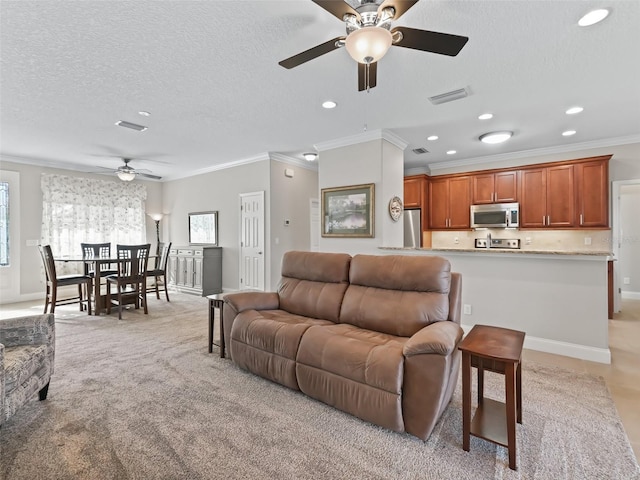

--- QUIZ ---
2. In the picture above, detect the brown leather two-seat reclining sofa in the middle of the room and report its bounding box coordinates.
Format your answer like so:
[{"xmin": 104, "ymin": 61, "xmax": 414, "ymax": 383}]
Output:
[{"xmin": 224, "ymin": 252, "xmax": 463, "ymax": 440}]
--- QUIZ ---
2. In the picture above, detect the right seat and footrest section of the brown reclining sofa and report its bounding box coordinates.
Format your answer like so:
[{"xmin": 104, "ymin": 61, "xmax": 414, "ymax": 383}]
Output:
[{"xmin": 296, "ymin": 324, "xmax": 406, "ymax": 431}]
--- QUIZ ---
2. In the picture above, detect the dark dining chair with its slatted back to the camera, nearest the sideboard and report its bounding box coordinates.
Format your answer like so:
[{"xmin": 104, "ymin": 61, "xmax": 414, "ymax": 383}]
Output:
[{"xmin": 106, "ymin": 243, "xmax": 151, "ymax": 319}]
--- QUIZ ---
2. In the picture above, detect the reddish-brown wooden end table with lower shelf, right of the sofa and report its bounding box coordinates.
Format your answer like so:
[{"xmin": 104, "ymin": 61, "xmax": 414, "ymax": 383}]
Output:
[{"xmin": 458, "ymin": 325, "xmax": 525, "ymax": 470}]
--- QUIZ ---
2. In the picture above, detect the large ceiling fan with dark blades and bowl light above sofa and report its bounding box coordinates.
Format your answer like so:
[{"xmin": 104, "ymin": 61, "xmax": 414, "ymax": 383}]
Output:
[{"xmin": 279, "ymin": 0, "xmax": 469, "ymax": 91}]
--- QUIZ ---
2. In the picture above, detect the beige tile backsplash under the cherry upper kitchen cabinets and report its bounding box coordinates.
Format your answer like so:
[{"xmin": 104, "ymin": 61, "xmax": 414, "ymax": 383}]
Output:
[{"xmin": 431, "ymin": 228, "xmax": 612, "ymax": 252}]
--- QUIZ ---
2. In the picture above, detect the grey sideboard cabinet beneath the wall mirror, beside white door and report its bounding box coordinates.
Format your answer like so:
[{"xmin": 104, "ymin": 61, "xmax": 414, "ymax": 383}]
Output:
[{"xmin": 167, "ymin": 245, "xmax": 222, "ymax": 297}]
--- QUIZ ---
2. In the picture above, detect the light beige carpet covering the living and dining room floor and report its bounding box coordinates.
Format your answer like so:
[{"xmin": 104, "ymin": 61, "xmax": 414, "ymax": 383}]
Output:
[{"xmin": 0, "ymin": 295, "xmax": 640, "ymax": 480}]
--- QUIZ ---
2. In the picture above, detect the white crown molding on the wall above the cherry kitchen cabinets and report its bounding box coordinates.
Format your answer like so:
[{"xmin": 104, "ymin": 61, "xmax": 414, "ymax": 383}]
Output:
[{"xmin": 427, "ymin": 135, "xmax": 640, "ymax": 173}]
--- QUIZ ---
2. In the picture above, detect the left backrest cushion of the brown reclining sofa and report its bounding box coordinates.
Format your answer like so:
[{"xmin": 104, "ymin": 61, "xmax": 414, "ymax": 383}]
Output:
[{"xmin": 278, "ymin": 251, "xmax": 351, "ymax": 322}]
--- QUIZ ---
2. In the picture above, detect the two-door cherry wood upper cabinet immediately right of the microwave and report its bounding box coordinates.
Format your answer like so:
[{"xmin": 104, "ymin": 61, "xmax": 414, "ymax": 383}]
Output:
[{"xmin": 520, "ymin": 164, "xmax": 576, "ymax": 228}]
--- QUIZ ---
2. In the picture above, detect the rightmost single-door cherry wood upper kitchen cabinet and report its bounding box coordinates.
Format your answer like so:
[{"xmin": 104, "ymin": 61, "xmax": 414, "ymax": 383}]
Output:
[{"xmin": 575, "ymin": 155, "xmax": 611, "ymax": 228}]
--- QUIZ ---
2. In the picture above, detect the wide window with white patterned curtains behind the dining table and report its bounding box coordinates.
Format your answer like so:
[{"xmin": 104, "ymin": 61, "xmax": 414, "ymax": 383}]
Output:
[{"xmin": 41, "ymin": 174, "xmax": 147, "ymax": 274}]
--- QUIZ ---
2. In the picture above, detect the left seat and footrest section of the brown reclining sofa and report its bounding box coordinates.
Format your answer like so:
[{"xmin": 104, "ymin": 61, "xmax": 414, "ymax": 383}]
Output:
[{"xmin": 230, "ymin": 310, "xmax": 333, "ymax": 390}]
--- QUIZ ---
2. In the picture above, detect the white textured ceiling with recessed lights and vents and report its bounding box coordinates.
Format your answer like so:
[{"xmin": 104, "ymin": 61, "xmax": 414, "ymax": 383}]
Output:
[{"xmin": 0, "ymin": 0, "xmax": 640, "ymax": 179}]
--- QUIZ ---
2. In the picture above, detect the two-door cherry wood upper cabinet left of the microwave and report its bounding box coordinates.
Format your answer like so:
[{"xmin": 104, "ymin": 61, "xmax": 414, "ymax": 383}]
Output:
[{"xmin": 428, "ymin": 175, "xmax": 471, "ymax": 230}]
